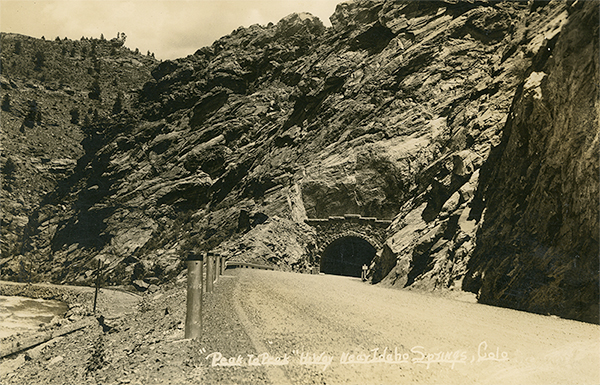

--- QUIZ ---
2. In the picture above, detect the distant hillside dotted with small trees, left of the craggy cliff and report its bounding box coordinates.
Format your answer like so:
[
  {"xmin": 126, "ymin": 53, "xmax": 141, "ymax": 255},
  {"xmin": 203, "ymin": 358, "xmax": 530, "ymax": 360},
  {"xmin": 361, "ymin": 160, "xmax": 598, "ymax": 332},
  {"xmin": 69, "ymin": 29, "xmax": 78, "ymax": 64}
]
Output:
[{"xmin": 0, "ymin": 33, "xmax": 156, "ymax": 271}]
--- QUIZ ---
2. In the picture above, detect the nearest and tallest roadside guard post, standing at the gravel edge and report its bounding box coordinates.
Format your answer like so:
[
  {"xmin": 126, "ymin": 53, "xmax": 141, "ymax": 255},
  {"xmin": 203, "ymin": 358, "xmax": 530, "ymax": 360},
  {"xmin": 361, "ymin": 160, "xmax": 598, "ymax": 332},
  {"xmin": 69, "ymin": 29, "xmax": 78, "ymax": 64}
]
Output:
[{"xmin": 185, "ymin": 255, "xmax": 203, "ymax": 339}]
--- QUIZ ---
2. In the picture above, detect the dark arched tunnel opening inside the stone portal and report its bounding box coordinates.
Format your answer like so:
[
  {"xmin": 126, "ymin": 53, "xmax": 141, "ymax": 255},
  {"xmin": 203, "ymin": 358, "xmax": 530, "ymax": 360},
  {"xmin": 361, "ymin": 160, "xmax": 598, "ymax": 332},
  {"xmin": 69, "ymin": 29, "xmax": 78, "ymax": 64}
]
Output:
[{"xmin": 320, "ymin": 236, "xmax": 377, "ymax": 277}]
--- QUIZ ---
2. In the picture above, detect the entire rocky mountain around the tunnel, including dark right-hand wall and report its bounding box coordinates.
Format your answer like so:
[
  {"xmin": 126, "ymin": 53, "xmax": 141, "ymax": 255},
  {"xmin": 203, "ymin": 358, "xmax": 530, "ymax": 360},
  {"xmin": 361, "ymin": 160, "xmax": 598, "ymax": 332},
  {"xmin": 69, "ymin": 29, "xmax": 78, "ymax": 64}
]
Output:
[{"xmin": 1, "ymin": 0, "xmax": 598, "ymax": 322}]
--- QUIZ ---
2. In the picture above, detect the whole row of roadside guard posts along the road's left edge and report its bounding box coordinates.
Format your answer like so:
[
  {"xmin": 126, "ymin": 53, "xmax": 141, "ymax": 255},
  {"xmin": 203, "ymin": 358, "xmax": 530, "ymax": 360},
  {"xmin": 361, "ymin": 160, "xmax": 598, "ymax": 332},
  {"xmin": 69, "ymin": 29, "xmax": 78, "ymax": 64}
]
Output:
[{"xmin": 185, "ymin": 252, "xmax": 226, "ymax": 339}]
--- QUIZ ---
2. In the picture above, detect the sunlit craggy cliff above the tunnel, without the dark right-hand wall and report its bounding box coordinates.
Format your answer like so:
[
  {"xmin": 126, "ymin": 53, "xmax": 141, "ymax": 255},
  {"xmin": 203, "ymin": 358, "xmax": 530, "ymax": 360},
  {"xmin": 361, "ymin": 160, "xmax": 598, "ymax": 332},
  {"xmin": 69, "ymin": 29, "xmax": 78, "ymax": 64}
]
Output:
[{"xmin": 2, "ymin": 0, "xmax": 597, "ymax": 317}]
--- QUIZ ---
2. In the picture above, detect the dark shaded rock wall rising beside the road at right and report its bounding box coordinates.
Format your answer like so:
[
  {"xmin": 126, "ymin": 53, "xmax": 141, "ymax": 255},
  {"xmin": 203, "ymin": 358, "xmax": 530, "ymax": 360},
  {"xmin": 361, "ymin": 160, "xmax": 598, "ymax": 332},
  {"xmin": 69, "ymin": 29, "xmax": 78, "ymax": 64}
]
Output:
[{"xmin": 465, "ymin": 2, "xmax": 600, "ymax": 323}]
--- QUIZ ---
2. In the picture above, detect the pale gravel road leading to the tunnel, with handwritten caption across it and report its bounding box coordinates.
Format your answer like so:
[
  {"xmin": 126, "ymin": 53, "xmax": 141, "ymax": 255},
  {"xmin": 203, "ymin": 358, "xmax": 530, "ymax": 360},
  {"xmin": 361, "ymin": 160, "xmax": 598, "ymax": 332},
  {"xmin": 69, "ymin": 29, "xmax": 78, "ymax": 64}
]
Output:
[{"xmin": 221, "ymin": 269, "xmax": 600, "ymax": 384}]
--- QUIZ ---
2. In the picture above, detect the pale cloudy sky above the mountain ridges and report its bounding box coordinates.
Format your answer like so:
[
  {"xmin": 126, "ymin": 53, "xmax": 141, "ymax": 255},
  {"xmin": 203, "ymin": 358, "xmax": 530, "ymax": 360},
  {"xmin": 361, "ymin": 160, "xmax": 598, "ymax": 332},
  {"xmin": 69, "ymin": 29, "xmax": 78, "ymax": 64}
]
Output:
[{"xmin": 0, "ymin": 0, "xmax": 344, "ymax": 60}]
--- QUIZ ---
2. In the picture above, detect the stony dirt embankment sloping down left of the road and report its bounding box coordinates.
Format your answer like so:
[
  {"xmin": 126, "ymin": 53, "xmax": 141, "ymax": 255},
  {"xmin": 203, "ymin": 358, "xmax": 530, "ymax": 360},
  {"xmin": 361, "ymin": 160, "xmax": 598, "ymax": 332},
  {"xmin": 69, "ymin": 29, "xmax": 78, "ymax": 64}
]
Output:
[{"xmin": 0, "ymin": 271, "xmax": 269, "ymax": 385}]
